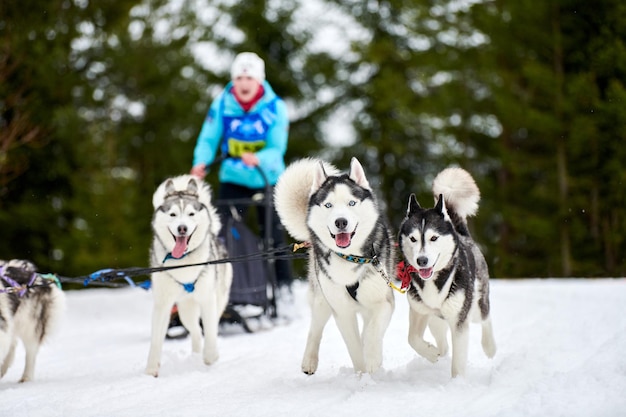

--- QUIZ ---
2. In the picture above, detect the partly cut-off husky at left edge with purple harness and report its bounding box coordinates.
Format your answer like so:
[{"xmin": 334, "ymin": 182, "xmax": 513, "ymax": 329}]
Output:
[{"xmin": 0, "ymin": 259, "xmax": 65, "ymax": 382}]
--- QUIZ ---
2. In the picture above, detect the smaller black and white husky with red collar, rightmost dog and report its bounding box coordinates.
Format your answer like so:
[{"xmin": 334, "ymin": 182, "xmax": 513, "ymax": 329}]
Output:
[{"xmin": 399, "ymin": 168, "xmax": 496, "ymax": 377}]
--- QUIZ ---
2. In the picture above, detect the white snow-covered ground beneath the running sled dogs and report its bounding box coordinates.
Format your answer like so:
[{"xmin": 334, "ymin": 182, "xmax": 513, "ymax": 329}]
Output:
[{"xmin": 0, "ymin": 279, "xmax": 626, "ymax": 417}]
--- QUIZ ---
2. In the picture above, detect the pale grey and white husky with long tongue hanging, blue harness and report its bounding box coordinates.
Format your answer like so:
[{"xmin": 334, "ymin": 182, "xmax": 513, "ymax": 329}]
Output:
[{"xmin": 146, "ymin": 175, "xmax": 233, "ymax": 377}]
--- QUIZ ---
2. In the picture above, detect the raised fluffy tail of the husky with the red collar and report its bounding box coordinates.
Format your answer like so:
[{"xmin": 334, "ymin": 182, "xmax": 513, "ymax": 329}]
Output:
[{"xmin": 433, "ymin": 168, "xmax": 480, "ymax": 220}]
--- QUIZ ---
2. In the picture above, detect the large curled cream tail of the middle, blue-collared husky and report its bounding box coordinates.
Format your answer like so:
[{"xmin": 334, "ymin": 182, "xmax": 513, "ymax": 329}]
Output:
[{"xmin": 274, "ymin": 158, "xmax": 339, "ymax": 241}]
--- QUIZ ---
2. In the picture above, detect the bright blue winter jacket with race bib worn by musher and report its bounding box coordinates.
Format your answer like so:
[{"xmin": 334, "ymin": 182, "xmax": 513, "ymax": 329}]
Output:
[{"xmin": 193, "ymin": 81, "xmax": 289, "ymax": 188}]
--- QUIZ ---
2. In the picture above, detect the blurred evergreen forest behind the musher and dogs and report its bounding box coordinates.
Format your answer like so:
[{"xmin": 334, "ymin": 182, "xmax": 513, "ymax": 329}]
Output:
[{"xmin": 0, "ymin": 0, "xmax": 626, "ymax": 278}]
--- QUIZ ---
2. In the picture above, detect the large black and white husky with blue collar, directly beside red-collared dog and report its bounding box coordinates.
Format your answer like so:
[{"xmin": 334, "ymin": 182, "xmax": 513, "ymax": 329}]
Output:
[{"xmin": 275, "ymin": 158, "xmax": 395, "ymax": 374}]
